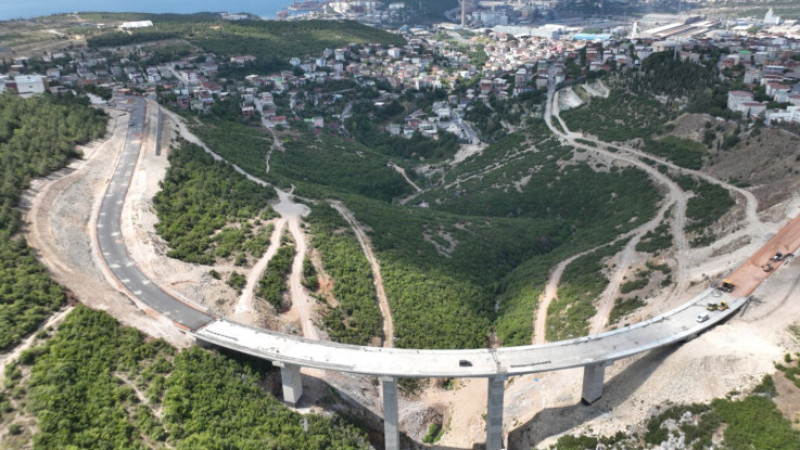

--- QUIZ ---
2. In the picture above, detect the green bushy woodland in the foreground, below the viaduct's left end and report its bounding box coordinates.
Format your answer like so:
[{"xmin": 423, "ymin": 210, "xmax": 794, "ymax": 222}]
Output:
[{"xmin": 0, "ymin": 307, "xmax": 369, "ymax": 450}]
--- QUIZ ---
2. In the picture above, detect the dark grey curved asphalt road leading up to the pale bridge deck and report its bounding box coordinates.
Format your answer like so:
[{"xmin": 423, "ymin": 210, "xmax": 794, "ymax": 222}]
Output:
[{"xmin": 97, "ymin": 98, "xmax": 214, "ymax": 330}]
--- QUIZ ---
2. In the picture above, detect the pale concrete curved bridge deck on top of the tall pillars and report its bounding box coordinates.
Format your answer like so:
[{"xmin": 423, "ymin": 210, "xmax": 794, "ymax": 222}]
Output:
[{"xmin": 194, "ymin": 289, "xmax": 746, "ymax": 377}]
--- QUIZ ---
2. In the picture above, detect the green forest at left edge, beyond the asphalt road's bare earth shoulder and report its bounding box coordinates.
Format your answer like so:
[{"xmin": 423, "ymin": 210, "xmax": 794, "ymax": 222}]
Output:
[{"xmin": 0, "ymin": 94, "xmax": 106, "ymax": 351}]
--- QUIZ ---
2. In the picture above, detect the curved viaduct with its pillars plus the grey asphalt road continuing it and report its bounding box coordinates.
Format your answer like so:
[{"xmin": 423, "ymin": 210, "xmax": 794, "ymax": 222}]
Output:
[{"xmin": 96, "ymin": 98, "xmax": 747, "ymax": 450}]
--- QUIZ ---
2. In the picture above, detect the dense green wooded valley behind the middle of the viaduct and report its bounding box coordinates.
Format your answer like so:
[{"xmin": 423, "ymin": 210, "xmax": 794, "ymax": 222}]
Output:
[{"xmin": 181, "ymin": 101, "xmax": 659, "ymax": 348}]
